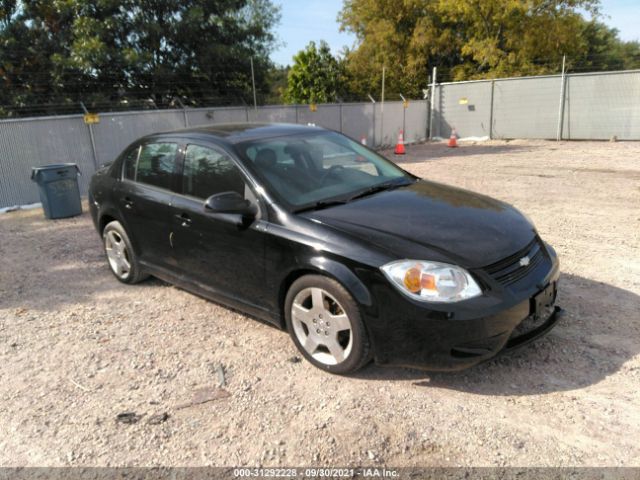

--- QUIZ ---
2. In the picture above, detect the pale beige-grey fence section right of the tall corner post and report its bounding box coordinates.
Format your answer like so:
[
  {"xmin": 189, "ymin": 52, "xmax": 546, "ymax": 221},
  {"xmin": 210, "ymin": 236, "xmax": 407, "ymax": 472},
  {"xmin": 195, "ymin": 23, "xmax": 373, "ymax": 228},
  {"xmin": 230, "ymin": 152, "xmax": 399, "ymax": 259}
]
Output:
[{"xmin": 431, "ymin": 70, "xmax": 640, "ymax": 140}]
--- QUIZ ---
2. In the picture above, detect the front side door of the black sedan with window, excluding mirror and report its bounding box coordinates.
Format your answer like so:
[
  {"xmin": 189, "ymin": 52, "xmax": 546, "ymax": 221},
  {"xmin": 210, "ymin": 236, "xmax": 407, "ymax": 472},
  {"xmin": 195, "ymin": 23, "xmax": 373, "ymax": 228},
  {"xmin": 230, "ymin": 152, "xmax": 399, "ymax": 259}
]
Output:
[{"xmin": 171, "ymin": 144, "xmax": 265, "ymax": 308}]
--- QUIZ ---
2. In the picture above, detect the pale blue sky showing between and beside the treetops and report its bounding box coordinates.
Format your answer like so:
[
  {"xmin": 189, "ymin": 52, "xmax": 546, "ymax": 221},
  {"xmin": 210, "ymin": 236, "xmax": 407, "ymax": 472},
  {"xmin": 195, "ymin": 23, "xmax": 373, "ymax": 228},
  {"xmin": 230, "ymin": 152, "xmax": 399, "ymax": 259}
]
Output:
[{"xmin": 271, "ymin": 0, "xmax": 640, "ymax": 65}]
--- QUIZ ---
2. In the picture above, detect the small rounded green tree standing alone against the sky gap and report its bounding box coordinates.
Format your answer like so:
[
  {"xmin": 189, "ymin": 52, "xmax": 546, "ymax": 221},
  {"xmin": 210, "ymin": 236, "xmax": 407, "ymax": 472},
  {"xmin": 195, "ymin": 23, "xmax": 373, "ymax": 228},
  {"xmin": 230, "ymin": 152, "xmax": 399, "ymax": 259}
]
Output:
[{"xmin": 285, "ymin": 41, "xmax": 344, "ymax": 103}]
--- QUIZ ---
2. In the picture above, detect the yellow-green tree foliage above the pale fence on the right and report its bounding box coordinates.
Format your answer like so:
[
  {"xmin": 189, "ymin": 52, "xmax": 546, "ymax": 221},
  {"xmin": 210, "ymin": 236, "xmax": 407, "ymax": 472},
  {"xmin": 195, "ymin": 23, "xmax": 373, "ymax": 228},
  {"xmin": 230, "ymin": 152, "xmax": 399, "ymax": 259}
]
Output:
[{"xmin": 339, "ymin": 0, "xmax": 640, "ymax": 96}]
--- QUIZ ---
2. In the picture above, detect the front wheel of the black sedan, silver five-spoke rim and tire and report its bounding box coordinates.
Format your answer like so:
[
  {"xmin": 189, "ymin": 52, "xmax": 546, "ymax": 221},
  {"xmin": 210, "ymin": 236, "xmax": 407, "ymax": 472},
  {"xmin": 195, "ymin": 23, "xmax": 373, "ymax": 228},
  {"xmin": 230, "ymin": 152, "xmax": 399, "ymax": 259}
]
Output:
[{"xmin": 285, "ymin": 275, "xmax": 371, "ymax": 374}]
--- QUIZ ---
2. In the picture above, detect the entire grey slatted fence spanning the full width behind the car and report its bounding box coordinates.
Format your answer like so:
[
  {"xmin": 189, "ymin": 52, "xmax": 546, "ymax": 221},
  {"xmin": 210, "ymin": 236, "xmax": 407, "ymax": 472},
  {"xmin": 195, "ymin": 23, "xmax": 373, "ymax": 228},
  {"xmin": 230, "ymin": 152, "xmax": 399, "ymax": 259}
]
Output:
[{"xmin": 0, "ymin": 70, "xmax": 640, "ymax": 208}]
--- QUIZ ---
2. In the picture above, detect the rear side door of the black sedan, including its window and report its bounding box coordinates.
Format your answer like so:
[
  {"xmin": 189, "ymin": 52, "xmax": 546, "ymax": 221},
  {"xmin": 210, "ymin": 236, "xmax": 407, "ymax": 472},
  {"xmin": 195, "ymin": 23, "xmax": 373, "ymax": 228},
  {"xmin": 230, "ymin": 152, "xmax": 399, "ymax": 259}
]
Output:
[{"xmin": 116, "ymin": 141, "xmax": 180, "ymax": 266}]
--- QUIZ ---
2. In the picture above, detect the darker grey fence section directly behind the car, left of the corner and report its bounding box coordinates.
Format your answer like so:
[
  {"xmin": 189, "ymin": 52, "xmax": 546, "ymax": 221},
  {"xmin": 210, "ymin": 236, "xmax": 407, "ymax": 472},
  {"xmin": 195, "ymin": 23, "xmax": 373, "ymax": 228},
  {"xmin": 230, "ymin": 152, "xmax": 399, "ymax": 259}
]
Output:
[{"xmin": 0, "ymin": 100, "xmax": 428, "ymax": 208}]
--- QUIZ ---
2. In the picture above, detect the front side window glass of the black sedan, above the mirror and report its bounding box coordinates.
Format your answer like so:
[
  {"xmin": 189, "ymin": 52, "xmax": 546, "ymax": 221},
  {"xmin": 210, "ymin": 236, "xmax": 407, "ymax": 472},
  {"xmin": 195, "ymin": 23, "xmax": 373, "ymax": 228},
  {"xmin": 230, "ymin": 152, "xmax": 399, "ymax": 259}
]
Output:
[{"xmin": 182, "ymin": 145, "xmax": 245, "ymax": 199}]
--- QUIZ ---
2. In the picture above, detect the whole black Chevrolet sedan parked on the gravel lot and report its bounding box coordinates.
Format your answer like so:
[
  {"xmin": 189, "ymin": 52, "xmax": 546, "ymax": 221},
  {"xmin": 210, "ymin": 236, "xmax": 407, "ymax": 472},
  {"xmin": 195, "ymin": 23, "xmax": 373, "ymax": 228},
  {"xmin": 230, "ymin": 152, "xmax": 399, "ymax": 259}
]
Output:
[{"xmin": 89, "ymin": 124, "xmax": 559, "ymax": 373}]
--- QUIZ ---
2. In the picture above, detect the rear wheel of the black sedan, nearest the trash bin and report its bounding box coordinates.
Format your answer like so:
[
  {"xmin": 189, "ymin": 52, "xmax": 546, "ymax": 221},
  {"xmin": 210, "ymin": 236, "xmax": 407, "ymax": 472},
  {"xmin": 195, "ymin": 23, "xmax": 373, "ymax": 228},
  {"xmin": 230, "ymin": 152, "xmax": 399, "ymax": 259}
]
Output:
[{"xmin": 102, "ymin": 220, "xmax": 149, "ymax": 284}]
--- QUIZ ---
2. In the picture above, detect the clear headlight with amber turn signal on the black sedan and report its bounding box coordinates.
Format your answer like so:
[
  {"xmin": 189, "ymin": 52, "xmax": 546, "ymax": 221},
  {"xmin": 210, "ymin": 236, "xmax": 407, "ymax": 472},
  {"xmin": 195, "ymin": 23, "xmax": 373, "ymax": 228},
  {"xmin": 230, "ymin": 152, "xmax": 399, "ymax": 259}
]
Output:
[{"xmin": 380, "ymin": 260, "xmax": 482, "ymax": 302}]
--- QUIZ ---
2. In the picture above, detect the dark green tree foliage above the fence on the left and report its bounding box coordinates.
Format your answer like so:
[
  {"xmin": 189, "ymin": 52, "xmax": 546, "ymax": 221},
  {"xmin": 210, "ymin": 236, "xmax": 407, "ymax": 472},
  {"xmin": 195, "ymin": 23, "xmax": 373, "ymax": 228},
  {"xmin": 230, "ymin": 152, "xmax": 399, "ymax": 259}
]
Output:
[{"xmin": 0, "ymin": 0, "xmax": 279, "ymax": 114}]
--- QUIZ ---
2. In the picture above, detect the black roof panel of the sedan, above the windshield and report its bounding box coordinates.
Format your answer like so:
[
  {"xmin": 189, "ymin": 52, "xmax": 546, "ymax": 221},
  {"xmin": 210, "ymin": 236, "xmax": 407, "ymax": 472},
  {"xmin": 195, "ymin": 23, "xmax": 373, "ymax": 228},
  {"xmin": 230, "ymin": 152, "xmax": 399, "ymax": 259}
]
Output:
[{"xmin": 145, "ymin": 123, "xmax": 324, "ymax": 144}]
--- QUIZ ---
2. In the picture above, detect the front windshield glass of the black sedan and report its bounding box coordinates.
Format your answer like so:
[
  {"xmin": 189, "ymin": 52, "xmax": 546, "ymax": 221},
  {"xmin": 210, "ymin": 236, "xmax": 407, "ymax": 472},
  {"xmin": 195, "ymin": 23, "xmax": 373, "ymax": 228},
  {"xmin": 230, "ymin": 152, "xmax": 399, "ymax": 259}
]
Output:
[{"xmin": 238, "ymin": 132, "xmax": 413, "ymax": 210}]
